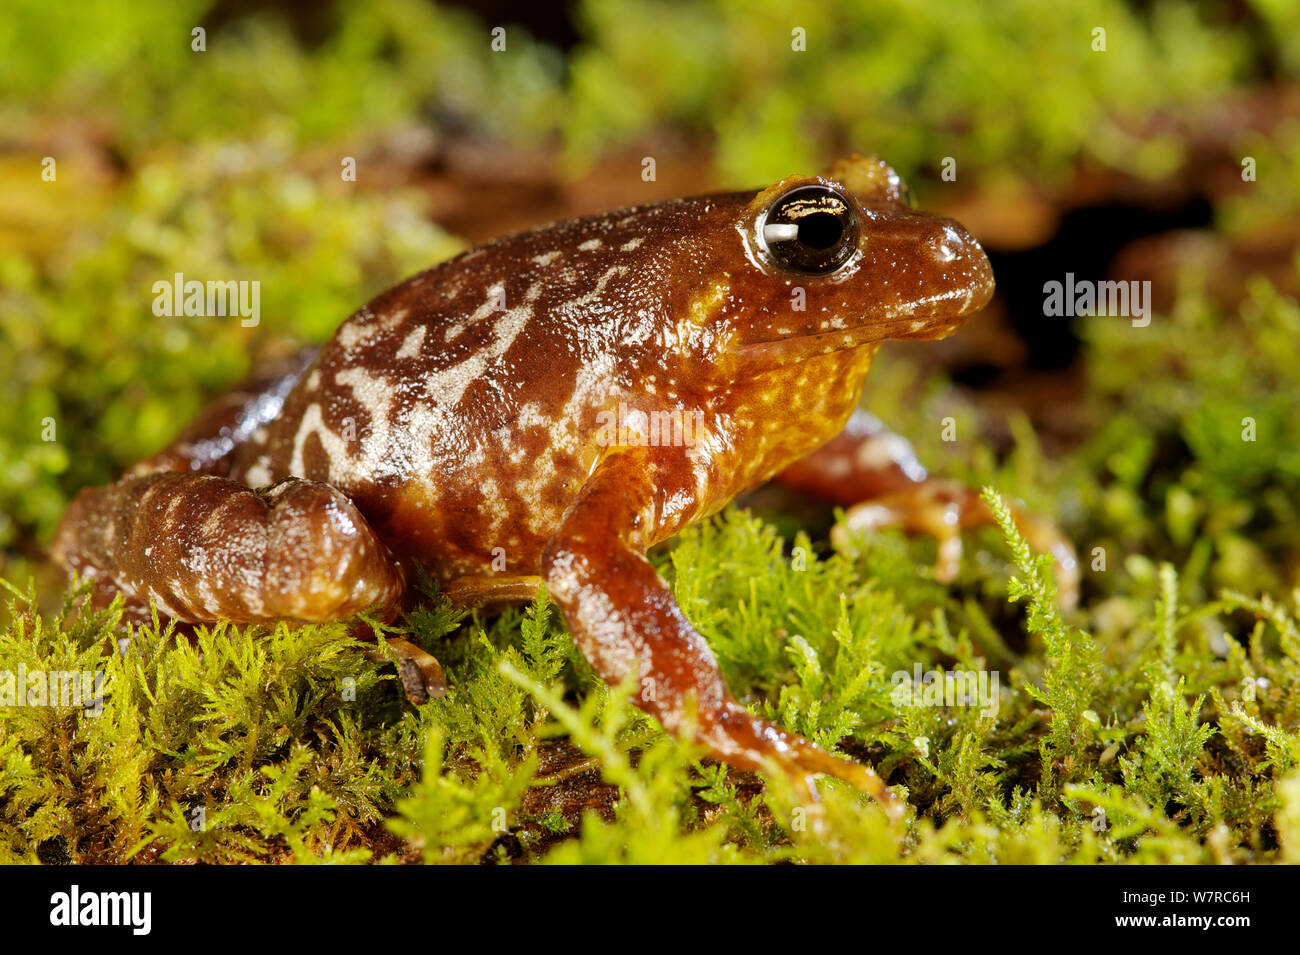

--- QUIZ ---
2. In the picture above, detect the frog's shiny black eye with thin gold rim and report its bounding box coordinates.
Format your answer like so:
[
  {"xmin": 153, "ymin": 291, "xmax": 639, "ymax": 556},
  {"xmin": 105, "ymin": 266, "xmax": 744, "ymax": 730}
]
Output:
[{"xmin": 759, "ymin": 186, "xmax": 858, "ymax": 275}]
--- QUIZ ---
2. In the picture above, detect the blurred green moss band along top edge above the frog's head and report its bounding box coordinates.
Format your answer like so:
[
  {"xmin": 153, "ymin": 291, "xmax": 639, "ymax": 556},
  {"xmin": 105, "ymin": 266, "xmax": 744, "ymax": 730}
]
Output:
[{"xmin": 566, "ymin": 0, "xmax": 1274, "ymax": 185}]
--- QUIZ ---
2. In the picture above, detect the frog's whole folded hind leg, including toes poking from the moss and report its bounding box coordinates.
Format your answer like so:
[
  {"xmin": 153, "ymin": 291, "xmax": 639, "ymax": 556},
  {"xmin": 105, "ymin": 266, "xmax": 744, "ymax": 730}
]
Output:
[{"xmin": 51, "ymin": 347, "xmax": 447, "ymax": 703}]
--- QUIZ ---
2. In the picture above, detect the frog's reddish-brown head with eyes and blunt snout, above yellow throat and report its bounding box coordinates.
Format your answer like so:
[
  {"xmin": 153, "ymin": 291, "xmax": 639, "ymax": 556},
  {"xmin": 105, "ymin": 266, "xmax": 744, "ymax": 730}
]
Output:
[{"xmin": 712, "ymin": 156, "xmax": 993, "ymax": 369}]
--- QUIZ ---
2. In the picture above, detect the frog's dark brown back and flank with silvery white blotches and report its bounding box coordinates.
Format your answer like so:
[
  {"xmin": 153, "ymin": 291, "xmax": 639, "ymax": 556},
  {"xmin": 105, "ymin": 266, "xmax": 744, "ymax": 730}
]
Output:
[{"xmin": 231, "ymin": 195, "xmax": 746, "ymax": 577}]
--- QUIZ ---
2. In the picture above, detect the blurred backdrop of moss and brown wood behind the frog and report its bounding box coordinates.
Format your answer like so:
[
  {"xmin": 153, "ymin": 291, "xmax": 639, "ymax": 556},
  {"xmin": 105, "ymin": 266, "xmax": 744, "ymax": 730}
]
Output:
[{"xmin": 0, "ymin": 0, "xmax": 1300, "ymax": 613}]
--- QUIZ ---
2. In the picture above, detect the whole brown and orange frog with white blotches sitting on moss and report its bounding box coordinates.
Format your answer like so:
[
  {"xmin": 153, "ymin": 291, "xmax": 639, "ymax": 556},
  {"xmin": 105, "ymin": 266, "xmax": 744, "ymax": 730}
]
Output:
[{"xmin": 52, "ymin": 155, "xmax": 1074, "ymax": 815}]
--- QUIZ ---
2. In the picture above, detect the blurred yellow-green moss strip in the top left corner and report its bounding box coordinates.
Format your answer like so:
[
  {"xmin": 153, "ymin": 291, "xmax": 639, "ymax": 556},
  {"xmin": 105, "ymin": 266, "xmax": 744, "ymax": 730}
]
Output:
[{"xmin": 0, "ymin": 0, "xmax": 562, "ymax": 155}]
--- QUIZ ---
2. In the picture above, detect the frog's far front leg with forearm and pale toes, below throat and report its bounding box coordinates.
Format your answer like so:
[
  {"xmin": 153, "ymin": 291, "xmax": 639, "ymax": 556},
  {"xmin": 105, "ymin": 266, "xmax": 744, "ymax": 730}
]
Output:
[{"xmin": 776, "ymin": 411, "xmax": 1079, "ymax": 608}]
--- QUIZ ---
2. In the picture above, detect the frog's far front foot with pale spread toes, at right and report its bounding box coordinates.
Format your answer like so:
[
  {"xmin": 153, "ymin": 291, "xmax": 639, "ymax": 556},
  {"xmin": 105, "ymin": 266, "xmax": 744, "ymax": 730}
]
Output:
[{"xmin": 831, "ymin": 478, "xmax": 1079, "ymax": 609}]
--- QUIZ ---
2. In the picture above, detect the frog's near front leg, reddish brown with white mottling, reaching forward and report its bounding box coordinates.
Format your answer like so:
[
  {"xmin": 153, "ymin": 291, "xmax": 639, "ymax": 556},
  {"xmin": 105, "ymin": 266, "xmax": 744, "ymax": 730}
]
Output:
[{"xmin": 543, "ymin": 450, "xmax": 902, "ymax": 817}]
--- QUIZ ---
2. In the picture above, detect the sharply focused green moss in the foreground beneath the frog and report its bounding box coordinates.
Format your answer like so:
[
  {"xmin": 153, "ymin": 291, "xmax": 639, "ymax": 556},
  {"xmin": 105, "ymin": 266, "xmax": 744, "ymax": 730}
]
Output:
[{"xmin": 0, "ymin": 446, "xmax": 1300, "ymax": 863}]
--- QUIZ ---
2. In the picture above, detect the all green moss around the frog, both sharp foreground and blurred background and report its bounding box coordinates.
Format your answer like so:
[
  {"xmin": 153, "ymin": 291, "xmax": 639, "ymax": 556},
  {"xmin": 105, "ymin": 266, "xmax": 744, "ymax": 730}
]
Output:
[{"xmin": 0, "ymin": 0, "xmax": 1300, "ymax": 863}]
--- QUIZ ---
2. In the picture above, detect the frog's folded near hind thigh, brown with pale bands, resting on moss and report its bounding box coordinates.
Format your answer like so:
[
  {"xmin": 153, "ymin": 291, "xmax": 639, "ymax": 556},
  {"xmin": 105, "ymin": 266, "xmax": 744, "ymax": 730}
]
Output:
[{"xmin": 52, "ymin": 472, "xmax": 403, "ymax": 622}]
